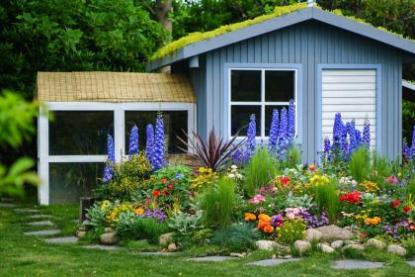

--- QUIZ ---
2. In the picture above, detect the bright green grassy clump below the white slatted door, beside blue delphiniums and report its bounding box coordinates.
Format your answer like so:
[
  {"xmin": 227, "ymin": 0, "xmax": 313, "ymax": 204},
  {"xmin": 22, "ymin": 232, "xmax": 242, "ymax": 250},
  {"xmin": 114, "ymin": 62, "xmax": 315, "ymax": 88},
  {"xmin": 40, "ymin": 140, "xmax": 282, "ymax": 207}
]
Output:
[{"xmin": 349, "ymin": 147, "xmax": 371, "ymax": 182}]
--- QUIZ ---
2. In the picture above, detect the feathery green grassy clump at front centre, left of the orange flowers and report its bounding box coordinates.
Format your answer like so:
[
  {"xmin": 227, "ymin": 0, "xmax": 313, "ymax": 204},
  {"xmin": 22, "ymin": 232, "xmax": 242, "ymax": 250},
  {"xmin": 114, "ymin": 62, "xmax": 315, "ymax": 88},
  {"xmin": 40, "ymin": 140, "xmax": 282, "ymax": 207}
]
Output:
[{"xmin": 198, "ymin": 177, "xmax": 236, "ymax": 228}]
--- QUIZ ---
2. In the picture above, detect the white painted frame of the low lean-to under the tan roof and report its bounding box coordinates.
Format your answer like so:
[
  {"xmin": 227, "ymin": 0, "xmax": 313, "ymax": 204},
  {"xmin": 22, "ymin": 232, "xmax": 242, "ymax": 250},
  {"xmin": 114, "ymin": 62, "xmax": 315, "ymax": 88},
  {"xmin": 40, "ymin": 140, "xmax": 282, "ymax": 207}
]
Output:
[{"xmin": 38, "ymin": 102, "xmax": 197, "ymax": 205}]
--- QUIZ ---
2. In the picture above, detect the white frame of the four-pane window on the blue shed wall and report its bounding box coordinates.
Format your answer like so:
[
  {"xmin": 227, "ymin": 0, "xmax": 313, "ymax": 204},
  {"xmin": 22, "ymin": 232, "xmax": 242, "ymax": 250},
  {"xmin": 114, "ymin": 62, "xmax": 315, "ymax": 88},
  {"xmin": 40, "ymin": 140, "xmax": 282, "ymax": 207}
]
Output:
[{"xmin": 227, "ymin": 67, "xmax": 299, "ymax": 141}]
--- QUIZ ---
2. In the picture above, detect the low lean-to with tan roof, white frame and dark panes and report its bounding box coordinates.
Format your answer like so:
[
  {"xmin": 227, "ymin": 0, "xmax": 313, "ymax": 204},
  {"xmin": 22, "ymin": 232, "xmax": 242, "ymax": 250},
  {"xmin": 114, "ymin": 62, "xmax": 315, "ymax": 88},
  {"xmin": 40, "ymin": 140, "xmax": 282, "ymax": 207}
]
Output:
[{"xmin": 37, "ymin": 72, "xmax": 196, "ymax": 204}]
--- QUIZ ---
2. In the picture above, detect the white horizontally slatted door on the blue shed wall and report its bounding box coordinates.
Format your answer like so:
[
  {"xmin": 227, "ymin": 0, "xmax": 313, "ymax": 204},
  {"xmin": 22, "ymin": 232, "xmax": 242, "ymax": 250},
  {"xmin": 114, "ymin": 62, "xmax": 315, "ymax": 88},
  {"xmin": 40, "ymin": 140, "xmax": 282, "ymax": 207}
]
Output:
[{"xmin": 322, "ymin": 69, "xmax": 377, "ymax": 149}]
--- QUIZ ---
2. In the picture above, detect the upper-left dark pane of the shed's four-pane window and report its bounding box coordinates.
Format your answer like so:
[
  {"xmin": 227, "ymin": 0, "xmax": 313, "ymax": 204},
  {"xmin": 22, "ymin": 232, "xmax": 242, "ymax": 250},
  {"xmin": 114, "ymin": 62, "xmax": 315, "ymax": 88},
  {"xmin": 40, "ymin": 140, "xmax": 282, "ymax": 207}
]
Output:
[{"xmin": 231, "ymin": 70, "xmax": 261, "ymax": 102}]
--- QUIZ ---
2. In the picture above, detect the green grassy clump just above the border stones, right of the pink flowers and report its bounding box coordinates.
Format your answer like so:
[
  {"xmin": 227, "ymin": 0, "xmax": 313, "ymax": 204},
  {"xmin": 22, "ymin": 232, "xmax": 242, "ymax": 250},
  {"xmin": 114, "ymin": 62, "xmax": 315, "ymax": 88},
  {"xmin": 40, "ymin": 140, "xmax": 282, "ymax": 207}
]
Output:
[{"xmin": 314, "ymin": 183, "xmax": 340, "ymax": 223}]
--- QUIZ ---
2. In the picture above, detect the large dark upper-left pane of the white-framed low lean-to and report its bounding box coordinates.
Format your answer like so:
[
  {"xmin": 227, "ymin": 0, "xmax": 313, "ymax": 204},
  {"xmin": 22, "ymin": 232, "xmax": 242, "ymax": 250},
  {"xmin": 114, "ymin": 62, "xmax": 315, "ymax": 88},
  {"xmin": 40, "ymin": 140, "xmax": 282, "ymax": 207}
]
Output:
[{"xmin": 49, "ymin": 111, "xmax": 114, "ymax": 155}]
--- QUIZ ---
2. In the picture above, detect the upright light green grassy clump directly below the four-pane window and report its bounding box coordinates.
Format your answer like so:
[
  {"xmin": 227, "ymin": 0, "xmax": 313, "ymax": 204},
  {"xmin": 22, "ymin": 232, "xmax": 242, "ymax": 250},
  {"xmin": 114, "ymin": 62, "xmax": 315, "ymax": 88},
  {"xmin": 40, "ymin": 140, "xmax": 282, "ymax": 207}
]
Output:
[{"xmin": 243, "ymin": 147, "xmax": 278, "ymax": 196}]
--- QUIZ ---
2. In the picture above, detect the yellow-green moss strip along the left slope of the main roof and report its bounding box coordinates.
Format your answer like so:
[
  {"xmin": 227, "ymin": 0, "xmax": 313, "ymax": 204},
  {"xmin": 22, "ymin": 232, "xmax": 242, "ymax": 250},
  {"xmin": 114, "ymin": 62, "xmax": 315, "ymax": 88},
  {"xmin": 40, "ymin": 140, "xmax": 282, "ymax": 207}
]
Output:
[{"xmin": 151, "ymin": 3, "xmax": 307, "ymax": 60}]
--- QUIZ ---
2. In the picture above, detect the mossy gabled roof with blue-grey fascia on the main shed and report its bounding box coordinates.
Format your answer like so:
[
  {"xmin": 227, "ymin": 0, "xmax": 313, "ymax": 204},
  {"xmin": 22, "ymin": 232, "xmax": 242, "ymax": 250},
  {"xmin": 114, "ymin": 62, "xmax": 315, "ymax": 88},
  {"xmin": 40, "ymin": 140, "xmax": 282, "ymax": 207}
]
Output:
[{"xmin": 147, "ymin": 4, "xmax": 415, "ymax": 70}]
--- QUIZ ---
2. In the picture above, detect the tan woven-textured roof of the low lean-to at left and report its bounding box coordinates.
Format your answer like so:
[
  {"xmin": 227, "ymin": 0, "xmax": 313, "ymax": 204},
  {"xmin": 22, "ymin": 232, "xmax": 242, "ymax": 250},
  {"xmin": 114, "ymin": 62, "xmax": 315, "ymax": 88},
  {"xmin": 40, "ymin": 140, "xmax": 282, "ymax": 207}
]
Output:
[{"xmin": 37, "ymin": 72, "xmax": 196, "ymax": 103}]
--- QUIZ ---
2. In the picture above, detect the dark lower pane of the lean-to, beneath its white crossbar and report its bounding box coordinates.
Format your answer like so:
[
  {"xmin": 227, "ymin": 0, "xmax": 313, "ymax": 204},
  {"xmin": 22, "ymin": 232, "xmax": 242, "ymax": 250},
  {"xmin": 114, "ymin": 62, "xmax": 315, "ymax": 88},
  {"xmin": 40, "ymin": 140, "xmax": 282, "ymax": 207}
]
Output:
[{"xmin": 49, "ymin": 163, "xmax": 105, "ymax": 204}]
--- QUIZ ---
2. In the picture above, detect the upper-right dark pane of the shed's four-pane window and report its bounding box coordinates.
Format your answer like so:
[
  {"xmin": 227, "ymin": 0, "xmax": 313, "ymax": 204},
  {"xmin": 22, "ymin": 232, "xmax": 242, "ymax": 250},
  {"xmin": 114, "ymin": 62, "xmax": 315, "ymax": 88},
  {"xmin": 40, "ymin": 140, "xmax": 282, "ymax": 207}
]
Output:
[{"xmin": 265, "ymin": 70, "xmax": 294, "ymax": 102}]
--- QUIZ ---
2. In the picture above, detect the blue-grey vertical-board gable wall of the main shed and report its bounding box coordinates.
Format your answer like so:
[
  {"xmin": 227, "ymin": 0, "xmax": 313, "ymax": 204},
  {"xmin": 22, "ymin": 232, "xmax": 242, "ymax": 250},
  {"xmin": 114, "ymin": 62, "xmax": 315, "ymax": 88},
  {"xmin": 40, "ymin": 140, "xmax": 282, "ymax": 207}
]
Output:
[{"xmin": 190, "ymin": 21, "xmax": 404, "ymax": 162}]
